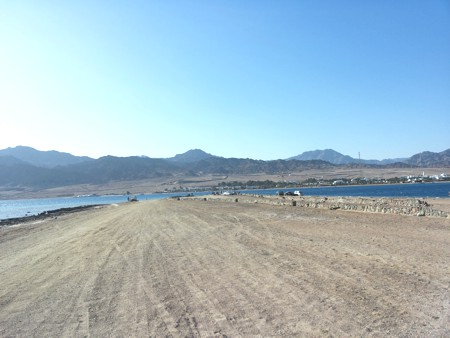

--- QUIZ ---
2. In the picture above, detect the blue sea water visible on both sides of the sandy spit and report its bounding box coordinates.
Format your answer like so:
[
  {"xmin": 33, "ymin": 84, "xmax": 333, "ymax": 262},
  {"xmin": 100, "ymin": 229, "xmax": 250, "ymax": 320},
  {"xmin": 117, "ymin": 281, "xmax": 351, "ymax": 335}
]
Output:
[{"xmin": 0, "ymin": 182, "xmax": 450, "ymax": 219}]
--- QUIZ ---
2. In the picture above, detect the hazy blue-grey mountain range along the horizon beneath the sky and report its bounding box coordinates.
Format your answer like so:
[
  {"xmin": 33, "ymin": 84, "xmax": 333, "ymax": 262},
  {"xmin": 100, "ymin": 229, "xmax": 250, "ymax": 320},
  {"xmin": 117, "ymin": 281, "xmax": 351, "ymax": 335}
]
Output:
[{"xmin": 0, "ymin": 146, "xmax": 450, "ymax": 189}]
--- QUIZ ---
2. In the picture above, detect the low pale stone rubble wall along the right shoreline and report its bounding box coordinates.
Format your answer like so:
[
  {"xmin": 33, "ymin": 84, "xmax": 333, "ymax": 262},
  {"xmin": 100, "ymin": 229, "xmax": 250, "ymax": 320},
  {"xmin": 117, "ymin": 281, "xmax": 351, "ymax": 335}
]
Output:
[{"xmin": 192, "ymin": 194, "xmax": 450, "ymax": 218}]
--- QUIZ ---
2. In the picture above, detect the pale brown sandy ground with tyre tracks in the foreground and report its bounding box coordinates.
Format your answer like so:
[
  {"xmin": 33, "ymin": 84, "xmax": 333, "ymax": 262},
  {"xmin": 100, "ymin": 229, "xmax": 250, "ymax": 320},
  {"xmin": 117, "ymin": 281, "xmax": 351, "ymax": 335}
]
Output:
[{"xmin": 0, "ymin": 199, "xmax": 450, "ymax": 337}]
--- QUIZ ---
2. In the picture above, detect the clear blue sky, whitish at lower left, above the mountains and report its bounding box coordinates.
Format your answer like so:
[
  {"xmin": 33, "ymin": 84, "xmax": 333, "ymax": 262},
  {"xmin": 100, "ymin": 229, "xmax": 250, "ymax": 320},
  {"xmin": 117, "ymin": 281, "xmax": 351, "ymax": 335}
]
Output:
[{"xmin": 0, "ymin": 0, "xmax": 450, "ymax": 160}]
